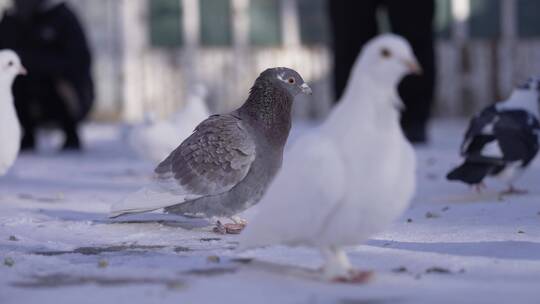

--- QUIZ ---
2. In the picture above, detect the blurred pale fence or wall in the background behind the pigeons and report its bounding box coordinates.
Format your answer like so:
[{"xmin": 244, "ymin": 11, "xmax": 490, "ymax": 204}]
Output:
[{"xmin": 0, "ymin": 0, "xmax": 540, "ymax": 122}]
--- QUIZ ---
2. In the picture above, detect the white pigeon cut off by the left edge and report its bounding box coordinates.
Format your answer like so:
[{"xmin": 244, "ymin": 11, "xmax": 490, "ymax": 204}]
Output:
[{"xmin": 0, "ymin": 50, "xmax": 26, "ymax": 175}]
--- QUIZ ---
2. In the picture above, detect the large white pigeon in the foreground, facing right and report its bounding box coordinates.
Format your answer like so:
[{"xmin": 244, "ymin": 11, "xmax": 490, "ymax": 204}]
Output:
[{"xmin": 239, "ymin": 34, "xmax": 420, "ymax": 280}]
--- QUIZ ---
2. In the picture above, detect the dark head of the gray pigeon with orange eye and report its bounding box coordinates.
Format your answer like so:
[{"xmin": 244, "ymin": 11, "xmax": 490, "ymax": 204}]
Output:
[{"xmin": 256, "ymin": 67, "xmax": 311, "ymax": 97}]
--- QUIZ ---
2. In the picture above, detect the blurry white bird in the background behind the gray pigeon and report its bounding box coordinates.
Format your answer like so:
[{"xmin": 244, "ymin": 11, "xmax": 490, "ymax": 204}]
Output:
[{"xmin": 128, "ymin": 84, "xmax": 210, "ymax": 164}]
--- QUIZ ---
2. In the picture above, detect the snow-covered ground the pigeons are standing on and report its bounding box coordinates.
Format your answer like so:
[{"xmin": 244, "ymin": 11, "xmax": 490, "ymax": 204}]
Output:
[{"xmin": 0, "ymin": 121, "xmax": 540, "ymax": 304}]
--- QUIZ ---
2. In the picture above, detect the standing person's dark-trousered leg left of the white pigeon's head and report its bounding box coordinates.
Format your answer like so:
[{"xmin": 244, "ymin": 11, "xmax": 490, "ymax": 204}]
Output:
[{"xmin": 328, "ymin": 0, "xmax": 379, "ymax": 101}]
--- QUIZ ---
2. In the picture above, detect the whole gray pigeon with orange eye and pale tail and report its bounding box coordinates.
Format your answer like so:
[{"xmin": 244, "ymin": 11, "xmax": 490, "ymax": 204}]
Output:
[{"xmin": 110, "ymin": 68, "xmax": 311, "ymax": 230}]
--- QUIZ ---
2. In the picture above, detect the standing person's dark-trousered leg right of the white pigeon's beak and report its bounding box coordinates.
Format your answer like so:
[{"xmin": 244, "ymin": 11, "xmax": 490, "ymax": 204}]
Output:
[{"xmin": 385, "ymin": 0, "xmax": 435, "ymax": 143}]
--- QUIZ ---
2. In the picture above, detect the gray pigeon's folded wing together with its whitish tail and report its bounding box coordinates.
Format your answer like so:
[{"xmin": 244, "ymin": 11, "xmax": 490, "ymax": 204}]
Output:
[{"xmin": 111, "ymin": 115, "xmax": 255, "ymax": 217}]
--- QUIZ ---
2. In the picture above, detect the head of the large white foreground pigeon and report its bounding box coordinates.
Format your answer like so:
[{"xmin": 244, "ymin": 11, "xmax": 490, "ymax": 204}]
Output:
[{"xmin": 353, "ymin": 34, "xmax": 422, "ymax": 87}]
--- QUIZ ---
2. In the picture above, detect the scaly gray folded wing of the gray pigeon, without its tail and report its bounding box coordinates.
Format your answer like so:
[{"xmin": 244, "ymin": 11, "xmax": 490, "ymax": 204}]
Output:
[{"xmin": 155, "ymin": 115, "xmax": 255, "ymax": 196}]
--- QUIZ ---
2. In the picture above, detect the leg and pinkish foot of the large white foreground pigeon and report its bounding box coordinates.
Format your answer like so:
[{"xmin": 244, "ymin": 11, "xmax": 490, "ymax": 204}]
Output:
[{"xmin": 321, "ymin": 247, "xmax": 372, "ymax": 284}]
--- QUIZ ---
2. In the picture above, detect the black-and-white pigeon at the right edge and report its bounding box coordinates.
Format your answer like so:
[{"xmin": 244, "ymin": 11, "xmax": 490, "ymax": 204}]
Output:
[{"xmin": 447, "ymin": 77, "xmax": 540, "ymax": 193}]
